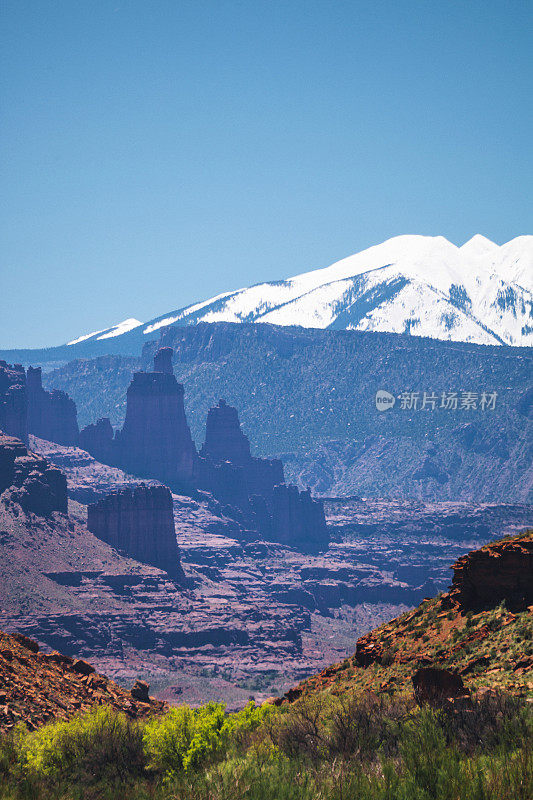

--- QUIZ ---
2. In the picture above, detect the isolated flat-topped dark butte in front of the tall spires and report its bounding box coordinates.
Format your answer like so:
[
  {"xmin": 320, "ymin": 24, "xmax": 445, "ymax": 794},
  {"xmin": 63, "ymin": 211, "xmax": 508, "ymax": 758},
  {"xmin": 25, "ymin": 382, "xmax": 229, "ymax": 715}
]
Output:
[{"xmin": 87, "ymin": 484, "xmax": 184, "ymax": 581}]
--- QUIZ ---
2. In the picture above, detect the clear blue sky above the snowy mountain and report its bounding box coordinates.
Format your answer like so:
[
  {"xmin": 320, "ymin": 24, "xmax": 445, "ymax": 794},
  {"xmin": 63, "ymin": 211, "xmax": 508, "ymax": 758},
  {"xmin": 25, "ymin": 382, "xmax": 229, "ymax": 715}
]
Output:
[{"xmin": 0, "ymin": 0, "xmax": 533, "ymax": 348}]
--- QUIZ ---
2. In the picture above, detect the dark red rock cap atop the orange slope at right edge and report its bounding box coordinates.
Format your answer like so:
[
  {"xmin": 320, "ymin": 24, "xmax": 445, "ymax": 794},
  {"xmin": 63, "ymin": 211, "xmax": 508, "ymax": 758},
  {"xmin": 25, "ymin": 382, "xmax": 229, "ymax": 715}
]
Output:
[{"xmin": 450, "ymin": 538, "xmax": 533, "ymax": 610}]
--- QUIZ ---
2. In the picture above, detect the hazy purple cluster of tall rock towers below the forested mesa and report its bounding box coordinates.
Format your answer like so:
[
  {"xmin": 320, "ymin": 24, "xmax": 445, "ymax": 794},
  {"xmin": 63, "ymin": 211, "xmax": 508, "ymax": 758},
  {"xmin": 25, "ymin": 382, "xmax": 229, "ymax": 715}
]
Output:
[{"xmin": 80, "ymin": 354, "xmax": 328, "ymax": 550}]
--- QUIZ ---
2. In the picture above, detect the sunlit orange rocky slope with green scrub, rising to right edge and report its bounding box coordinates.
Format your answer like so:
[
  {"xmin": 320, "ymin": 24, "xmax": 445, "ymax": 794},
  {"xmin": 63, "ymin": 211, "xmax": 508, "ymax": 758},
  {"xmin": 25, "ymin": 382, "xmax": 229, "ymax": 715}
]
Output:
[{"xmin": 275, "ymin": 530, "xmax": 533, "ymax": 705}]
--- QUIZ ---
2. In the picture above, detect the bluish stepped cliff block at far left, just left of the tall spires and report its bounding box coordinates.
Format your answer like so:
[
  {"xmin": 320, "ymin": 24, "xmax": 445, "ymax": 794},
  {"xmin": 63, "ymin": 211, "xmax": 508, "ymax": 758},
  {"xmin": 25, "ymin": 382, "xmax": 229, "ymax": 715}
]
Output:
[{"xmin": 26, "ymin": 367, "xmax": 79, "ymax": 447}]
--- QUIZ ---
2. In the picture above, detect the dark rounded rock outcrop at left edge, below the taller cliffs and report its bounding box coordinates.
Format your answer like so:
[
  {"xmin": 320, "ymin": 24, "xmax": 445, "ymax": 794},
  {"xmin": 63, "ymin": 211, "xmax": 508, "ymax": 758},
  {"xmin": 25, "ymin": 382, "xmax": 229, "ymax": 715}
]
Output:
[{"xmin": 0, "ymin": 434, "xmax": 67, "ymax": 516}]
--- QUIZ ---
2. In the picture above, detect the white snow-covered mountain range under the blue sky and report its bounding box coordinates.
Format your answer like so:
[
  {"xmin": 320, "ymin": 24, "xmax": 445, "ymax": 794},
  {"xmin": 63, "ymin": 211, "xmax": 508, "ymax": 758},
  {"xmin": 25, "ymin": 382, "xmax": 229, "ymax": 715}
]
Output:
[{"xmin": 69, "ymin": 235, "xmax": 533, "ymax": 345}]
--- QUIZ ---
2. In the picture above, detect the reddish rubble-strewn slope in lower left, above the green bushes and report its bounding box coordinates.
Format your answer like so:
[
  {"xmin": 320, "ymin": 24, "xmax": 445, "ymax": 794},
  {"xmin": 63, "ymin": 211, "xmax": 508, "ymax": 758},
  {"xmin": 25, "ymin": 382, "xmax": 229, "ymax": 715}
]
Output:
[{"xmin": 0, "ymin": 631, "xmax": 167, "ymax": 733}]
